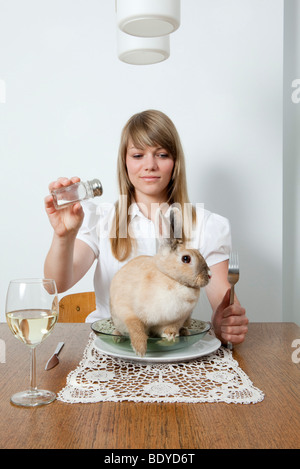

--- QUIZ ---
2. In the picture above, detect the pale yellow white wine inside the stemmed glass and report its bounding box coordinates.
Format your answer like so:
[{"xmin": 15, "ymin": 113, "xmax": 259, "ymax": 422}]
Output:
[{"xmin": 6, "ymin": 309, "xmax": 58, "ymax": 346}]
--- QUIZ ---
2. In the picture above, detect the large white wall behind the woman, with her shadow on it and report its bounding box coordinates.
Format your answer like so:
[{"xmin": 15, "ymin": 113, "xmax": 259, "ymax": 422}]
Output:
[{"xmin": 0, "ymin": 0, "xmax": 289, "ymax": 321}]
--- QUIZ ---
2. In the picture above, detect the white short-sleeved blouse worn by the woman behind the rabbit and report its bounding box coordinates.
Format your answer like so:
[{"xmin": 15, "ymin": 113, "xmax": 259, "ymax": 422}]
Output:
[{"xmin": 77, "ymin": 201, "xmax": 231, "ymax": 322}]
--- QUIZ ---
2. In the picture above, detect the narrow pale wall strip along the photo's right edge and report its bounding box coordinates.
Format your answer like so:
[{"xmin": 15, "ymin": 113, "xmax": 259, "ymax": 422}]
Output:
[{"xmin": 283, "ymin": 0, "xmax": 300, "ymax": 324}]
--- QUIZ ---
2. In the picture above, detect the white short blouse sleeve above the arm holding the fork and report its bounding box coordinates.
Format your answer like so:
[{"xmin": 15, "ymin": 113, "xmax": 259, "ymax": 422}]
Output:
[{"xmin": 200, "ymin": 212, "xmax": 231, "ymax": 267}]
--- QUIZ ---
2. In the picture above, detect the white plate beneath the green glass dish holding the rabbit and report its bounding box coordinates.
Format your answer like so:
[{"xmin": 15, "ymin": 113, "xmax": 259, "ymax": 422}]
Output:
[{"xmin": 94, "ymin": 334, "xmax": 221, "ymax": 363}]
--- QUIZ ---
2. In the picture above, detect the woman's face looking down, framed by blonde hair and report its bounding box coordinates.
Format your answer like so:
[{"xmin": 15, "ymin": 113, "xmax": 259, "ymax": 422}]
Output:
[{"xmin": 126, "ymin": 140, "xmax": 174, "ymax": 202}]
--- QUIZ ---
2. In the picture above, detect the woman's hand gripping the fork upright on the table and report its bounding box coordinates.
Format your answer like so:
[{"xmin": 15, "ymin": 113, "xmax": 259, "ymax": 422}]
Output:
[{"xmin": 212, "ymin": 288, "xmax": 249, "ymax": 344}]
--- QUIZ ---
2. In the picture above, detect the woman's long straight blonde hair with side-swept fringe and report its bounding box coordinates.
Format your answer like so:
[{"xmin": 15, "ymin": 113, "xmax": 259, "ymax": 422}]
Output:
[{"xmin": 110, "ymin": 110, "xmax": 195, "ymax": 261}]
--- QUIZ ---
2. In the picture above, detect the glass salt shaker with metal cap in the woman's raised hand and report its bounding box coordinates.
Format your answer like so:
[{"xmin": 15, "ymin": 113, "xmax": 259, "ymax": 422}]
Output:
[{"xmin": 51, "ymin": 179, "xmax": 103, "ymax": 210}]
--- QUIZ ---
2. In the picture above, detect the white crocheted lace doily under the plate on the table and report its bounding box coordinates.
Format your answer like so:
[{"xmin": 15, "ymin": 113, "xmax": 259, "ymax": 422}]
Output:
[{"xmin": 57, "ymin": 333, "xmax": 264, "ymax": 404}]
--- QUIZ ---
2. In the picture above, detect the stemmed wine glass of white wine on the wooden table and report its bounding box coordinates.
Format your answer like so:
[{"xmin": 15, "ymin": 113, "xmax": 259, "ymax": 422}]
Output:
[{"xmin": 5, "ymin": 278, "xmax": 58, "ymax": 407}]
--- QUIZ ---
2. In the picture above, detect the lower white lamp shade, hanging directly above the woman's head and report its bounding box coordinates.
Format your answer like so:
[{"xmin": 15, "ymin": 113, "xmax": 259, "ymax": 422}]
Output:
[{"xmin": 117, "ymin": 31, "xmax": 170, "ymax": 65}]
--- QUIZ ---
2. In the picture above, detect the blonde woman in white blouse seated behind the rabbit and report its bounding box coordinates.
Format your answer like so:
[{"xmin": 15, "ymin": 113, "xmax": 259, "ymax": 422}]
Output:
[{"xmin": 45, "ymin": 110, "xmax": 248, "ymax": 344}]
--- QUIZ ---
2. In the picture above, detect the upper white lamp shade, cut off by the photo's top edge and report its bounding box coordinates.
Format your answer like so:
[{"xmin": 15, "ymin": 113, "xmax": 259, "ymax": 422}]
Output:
[{"xmin": 116, "ymin": 0, "xmax": 180, "ymax": 37}]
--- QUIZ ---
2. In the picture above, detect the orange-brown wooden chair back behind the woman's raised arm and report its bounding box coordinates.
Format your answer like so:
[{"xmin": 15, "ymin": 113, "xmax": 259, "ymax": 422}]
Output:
[{"xmin": 58, "ymin": 292, "xmax": 96, "ymax": 322}]
